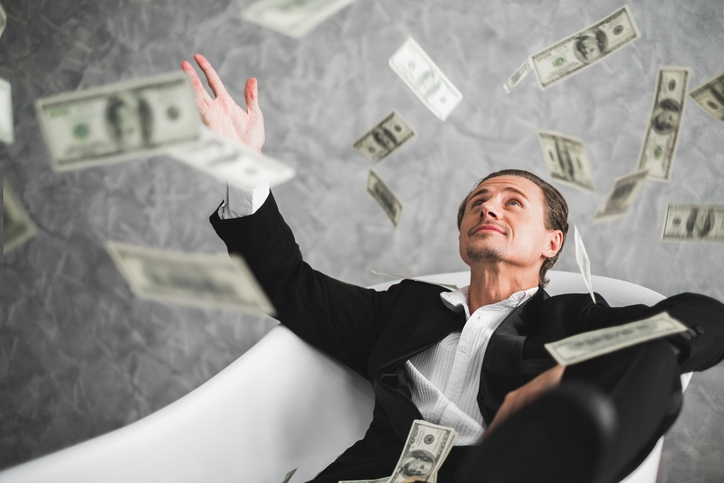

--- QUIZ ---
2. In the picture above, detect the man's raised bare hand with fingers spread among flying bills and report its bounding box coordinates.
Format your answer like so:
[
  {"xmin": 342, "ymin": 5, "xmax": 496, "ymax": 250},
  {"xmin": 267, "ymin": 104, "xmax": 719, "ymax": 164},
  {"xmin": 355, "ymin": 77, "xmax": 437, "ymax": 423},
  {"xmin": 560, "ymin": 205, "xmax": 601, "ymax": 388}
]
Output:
[{"xmin": 181, "ymin": 54, "xmax": 265, "ymax": 153}]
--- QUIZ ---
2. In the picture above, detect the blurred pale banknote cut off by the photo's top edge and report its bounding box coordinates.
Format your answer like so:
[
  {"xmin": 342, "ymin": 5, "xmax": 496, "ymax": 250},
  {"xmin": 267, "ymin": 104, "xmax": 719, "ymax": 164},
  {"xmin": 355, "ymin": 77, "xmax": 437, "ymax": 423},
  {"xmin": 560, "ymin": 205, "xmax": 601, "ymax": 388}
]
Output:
[{"xmin": 242, "ymin": 0, "xmax": 354, "ymax": 39}]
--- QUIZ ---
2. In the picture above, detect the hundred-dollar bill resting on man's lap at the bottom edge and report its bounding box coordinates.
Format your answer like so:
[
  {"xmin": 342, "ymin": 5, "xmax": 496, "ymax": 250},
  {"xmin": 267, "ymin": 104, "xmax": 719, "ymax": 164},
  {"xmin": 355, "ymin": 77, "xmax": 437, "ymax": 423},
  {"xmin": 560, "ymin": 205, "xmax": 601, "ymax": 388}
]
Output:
[{"xmin": 389, "ymin": 419, "xmax": 458, "ymax": 483}]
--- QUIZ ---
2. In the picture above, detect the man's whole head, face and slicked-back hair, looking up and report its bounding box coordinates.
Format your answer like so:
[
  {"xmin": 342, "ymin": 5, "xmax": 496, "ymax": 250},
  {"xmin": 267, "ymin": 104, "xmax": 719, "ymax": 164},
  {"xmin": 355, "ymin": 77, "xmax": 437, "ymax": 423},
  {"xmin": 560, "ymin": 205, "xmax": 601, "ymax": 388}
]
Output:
[{"xmin": 457, "ymin": 169, "xmax": 568, "ymax": 286}]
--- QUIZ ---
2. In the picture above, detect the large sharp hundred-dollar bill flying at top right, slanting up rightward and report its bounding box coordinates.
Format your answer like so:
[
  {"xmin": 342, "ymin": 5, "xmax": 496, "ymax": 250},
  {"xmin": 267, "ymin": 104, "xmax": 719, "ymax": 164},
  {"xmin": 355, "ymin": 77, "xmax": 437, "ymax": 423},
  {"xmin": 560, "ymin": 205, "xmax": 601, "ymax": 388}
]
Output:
[{"xmin": 531, "ymin": 5, "xmax": 641, "ymax": 90}]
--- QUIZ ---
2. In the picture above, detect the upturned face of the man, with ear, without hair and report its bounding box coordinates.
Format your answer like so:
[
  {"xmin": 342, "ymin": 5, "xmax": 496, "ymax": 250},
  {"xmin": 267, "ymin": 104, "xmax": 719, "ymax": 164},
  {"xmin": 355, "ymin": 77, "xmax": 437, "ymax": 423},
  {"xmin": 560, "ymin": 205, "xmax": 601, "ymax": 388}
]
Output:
[{"xmin": 459, "ymin": 175, "xmax": 562, "ymax": 274}]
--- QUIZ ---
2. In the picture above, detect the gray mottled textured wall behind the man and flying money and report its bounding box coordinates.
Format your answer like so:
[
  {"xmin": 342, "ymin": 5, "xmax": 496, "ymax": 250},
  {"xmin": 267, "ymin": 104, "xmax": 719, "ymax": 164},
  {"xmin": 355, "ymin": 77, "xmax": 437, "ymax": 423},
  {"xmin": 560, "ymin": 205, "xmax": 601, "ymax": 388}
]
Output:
[{"xmin": 0, "ymin": 0, "xmax": 724, "ymax": 482}]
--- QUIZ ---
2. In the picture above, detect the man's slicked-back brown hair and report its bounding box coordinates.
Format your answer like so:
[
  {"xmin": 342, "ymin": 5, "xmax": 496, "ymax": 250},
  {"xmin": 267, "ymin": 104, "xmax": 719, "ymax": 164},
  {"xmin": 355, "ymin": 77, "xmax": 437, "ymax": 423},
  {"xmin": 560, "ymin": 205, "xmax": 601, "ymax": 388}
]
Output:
[{"xmin": 458, "ymin": 169, "xmax": 568, "ymax": 287}]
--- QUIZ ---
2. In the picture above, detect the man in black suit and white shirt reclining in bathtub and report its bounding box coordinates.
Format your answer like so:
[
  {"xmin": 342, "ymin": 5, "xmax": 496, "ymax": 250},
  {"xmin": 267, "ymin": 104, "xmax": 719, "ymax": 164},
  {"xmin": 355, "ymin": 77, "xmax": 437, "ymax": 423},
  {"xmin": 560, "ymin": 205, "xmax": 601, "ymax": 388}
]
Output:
[{"xmin": 182, "ymin": 55, "xmax": 724, "ymax": 483}]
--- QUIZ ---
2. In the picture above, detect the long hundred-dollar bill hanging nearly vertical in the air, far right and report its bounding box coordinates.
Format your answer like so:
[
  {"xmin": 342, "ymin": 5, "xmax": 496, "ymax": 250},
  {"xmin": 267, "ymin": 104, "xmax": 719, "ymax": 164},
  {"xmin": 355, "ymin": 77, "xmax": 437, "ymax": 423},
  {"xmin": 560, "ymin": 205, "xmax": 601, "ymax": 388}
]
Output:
[{"xmin": 636, "ymin": 67, "xmax": 689, "ymax": 181}]
